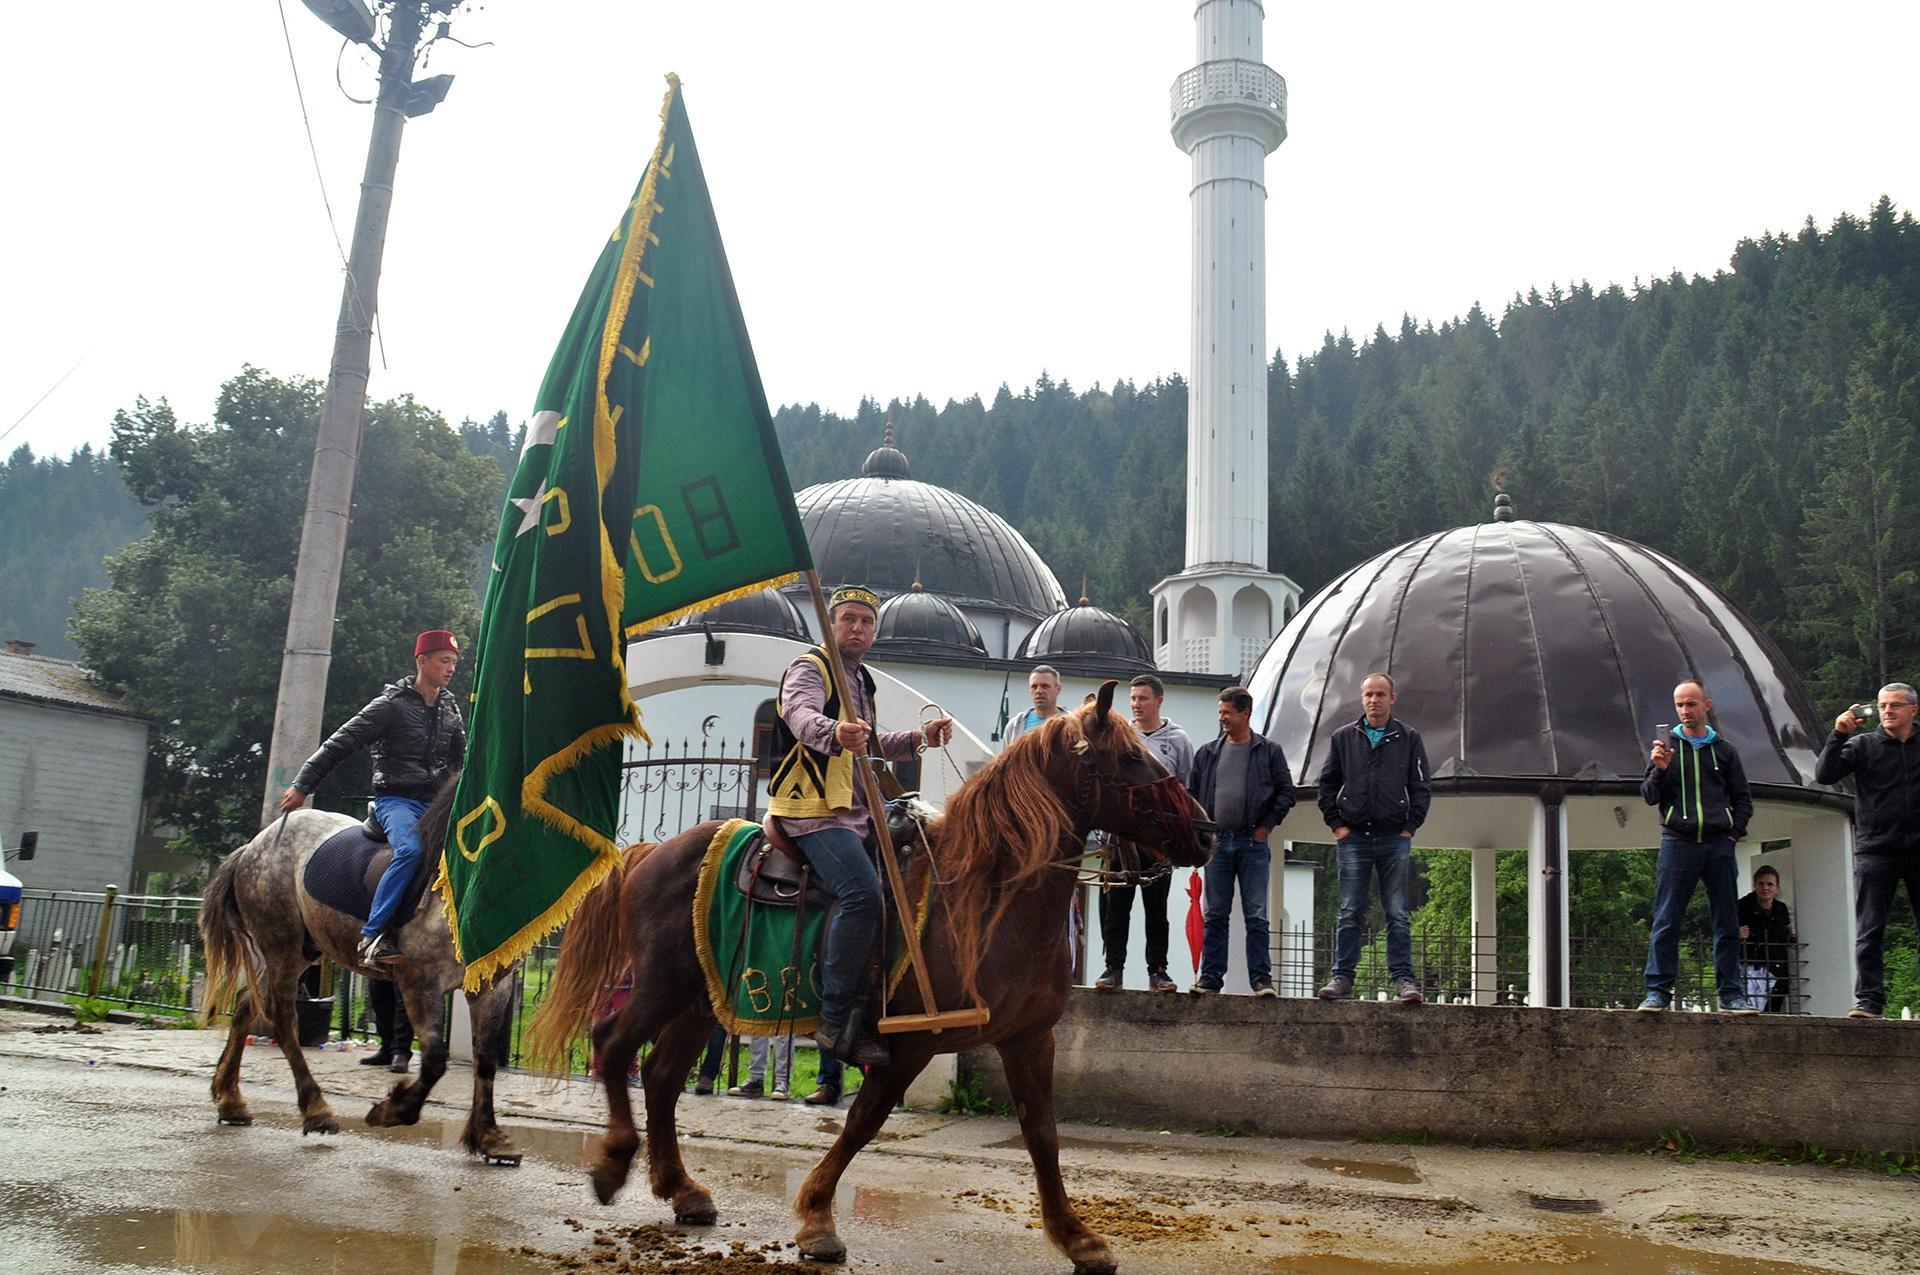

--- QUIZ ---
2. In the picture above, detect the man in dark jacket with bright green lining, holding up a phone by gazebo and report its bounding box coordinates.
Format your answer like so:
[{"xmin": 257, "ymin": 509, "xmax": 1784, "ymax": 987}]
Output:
[{"xmin": 1640, "ymin": 680, "xmax": 1755, "ymax": 1014}]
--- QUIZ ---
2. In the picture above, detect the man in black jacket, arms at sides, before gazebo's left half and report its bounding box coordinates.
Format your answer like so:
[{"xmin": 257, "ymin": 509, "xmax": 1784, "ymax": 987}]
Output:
[{"xmin": 1319, "ymin": 672, "xmax": 1432, "ymax": 1004}]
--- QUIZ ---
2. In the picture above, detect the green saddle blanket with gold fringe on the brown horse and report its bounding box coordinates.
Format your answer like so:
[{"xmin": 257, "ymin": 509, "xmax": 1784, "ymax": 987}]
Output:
[{"xmin": 693, "ymin": 820, "xmax": 933, "ymax": 1037}]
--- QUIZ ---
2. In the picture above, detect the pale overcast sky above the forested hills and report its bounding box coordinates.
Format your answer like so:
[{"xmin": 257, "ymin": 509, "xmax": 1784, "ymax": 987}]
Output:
[{"xmin": 0, "ymin": 0, "xmax": 1920, "ymax": 455}]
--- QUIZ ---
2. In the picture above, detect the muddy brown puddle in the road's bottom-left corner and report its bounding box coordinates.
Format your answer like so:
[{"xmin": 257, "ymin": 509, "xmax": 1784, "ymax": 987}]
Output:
[{"xmin": 0, "ymin": 1210, "xmax": 553, "ymax": 1275}]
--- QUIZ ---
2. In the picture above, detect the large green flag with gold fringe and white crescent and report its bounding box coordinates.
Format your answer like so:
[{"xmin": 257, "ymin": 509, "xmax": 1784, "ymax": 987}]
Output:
[{"xmin": 436, "ymin": 77, "xmax": 812, "ymax": 989}]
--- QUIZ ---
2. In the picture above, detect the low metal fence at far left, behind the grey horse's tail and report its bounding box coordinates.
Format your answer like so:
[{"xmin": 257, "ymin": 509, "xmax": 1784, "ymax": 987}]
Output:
[{"xmin": 0, "ymin": 887, "xmax": 205, "ymax": 1014}]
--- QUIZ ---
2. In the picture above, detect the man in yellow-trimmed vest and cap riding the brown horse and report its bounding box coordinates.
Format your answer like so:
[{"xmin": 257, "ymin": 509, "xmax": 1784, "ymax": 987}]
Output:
[{"xmin": 766, "ymin": 586, "xmax": 952, "ymax": 1066}]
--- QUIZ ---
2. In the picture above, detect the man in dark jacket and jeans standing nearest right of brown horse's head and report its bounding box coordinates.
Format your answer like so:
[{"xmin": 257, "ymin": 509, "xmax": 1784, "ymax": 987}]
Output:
[{"xmin": 1187, "ymin": 686, "xmax": 1294, "ymax": 997}]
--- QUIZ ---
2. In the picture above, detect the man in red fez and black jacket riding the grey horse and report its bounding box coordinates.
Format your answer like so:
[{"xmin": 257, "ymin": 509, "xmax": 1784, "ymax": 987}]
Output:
[{"xmin": 280, "ymin": 628, "xmax": 467, "ymax": 966}]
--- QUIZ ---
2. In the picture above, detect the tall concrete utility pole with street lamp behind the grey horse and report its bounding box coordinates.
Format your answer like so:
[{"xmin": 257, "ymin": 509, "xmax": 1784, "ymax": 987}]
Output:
[{"xmin": 261, "ymin": 0, "xmax": 459, "ymax": 824}]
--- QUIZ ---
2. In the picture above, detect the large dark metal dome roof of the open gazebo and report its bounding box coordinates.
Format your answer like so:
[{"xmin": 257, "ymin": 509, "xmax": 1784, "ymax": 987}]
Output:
[{"xmin": 1248, "ymin": 495, "xmax": 1834, "ymax": 799}]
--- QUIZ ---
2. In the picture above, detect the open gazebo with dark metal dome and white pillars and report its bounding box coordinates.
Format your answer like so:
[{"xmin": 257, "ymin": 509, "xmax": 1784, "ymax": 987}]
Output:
[{"xmin": 1250, "ymin": 495, "xmax": 1853, "ymax": 1012}]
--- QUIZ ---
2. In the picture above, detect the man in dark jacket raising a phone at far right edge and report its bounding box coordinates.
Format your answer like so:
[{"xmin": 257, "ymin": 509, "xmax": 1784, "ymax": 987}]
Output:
[{"xmin": 1812, "ymin": 682, "xmax": 1920, "ymax": 1018}]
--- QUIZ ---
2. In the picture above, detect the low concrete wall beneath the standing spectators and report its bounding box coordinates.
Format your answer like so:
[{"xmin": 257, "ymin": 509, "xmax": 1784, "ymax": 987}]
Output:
[{"xmin": 962, "ymin": 993, "xmax": 1920, "ymax": 1150}]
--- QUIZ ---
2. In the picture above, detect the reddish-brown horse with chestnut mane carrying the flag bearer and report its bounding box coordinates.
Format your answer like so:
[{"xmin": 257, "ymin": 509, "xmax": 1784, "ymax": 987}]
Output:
[{"xmin": 528, "ymin": 682, "xmax": 1212, "ymax": 1271}]
